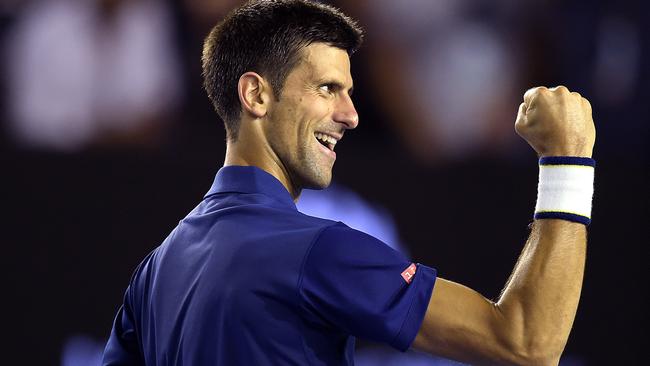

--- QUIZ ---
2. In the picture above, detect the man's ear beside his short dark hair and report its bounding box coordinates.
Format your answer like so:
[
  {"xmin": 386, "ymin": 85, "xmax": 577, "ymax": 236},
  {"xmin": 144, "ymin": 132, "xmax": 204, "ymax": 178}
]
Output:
[{"xmin": 237, "ymin": 71, "xmax": 271, "ymax": 118}]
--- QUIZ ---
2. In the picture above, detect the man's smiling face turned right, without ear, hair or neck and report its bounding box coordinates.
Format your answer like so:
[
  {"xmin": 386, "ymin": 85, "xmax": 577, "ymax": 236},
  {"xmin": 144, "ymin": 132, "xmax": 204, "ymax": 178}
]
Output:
[{"xmin": 264, "ymin": 43, "xmax": 359, "ymax": 192}]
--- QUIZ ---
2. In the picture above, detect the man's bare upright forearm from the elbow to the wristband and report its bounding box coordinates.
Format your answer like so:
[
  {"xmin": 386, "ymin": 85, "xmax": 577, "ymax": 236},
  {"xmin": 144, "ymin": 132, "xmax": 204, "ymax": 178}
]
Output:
[{"xmin": 496, "ymin": 219, "xmax": 587, "ymax": 364}]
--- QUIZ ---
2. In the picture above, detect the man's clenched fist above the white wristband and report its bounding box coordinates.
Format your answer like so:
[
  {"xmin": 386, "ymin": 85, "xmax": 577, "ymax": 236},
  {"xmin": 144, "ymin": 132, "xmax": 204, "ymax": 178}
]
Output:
[{"xmin": 515, "ymin": 86, "xmax": 596, "ymax": 157}]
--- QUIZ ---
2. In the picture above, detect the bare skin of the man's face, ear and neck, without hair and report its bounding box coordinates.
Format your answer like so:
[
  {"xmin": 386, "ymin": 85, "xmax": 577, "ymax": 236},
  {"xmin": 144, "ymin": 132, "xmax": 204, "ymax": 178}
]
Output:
[{"xmin": 221, "ymin": 41, "xmax": 359, "ymax": 200}]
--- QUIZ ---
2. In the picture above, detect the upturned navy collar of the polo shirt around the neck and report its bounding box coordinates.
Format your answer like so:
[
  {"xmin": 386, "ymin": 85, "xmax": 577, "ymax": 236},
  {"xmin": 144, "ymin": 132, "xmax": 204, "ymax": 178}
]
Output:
[{"xmin": 204, "ymin": 165, "xmax": 297, "ymax": 210}]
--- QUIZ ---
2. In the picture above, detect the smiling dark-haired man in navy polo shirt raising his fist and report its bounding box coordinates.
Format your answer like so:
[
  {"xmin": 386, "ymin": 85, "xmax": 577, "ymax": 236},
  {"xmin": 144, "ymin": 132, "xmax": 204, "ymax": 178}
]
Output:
[{"xmin": 104, "ymin": 0, "xmax": 595, "ymax": 365}]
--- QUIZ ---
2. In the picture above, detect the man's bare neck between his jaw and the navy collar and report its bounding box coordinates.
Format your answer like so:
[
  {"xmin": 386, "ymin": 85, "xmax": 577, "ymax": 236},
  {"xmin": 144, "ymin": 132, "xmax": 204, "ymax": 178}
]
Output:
[{"xmin": 223, "ymin": 134, "xmax": 302, "ymax": 202}]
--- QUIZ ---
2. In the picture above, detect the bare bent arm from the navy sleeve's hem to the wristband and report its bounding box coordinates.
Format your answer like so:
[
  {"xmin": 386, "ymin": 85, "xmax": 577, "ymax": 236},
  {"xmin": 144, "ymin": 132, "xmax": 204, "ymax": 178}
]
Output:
[{"xmin": 413, "ymin": 219, "xmax": 586, "ymax": 365}]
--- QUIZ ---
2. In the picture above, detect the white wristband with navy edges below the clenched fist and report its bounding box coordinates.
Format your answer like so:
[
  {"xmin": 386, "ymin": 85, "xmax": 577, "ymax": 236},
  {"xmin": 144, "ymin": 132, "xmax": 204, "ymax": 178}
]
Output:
[{"xmin": 534, "ymin": 156, "xmax": 596, "ymax": 225}]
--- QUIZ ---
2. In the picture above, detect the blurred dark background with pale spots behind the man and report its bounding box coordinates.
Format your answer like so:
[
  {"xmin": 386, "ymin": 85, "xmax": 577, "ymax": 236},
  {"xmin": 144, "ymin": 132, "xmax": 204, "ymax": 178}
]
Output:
[{"xmin": 0, "ymin": 0, "xmax": 650, "ymax": 365}]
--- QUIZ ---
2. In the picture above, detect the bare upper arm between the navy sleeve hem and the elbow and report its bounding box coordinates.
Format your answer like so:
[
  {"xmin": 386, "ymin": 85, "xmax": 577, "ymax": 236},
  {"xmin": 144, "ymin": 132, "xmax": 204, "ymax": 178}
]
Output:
[{"xmin": 413, "ymin": 278, "xmax": 510, "ymax": 364}]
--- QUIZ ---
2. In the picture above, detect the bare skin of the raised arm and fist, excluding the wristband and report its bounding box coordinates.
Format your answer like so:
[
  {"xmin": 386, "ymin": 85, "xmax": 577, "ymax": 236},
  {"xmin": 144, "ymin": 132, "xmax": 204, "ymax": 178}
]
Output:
[{"xmin": 413, "ymin": 86, "xmax": 595, "ymax": 365}]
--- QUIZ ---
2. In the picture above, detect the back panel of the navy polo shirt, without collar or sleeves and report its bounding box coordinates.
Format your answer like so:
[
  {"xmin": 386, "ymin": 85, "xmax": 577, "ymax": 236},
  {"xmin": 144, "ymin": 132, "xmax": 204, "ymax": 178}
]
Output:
[{"xmin": 109, "ymin": 195, "xmax": 348, "ymax": 365}]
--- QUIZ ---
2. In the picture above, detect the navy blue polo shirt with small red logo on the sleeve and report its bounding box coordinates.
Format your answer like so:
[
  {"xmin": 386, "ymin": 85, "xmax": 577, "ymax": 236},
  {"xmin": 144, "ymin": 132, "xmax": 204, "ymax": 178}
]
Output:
[{"xmin": 103, "ymin": 166, "xmax": 436, "ymax": 366}]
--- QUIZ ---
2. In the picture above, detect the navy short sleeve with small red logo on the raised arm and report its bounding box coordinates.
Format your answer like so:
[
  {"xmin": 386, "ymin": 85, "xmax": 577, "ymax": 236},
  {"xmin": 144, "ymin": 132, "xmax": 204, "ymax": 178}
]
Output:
[{"xmin": 299, "ymin": 223, "xmax": 436, "ymax": 351}]
